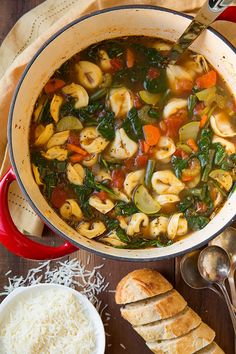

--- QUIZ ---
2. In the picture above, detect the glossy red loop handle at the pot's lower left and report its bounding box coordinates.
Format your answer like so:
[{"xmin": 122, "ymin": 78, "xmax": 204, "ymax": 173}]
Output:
[{"xmin": 0, "ymin": 168, "xmax": 78, "ymax": 260}]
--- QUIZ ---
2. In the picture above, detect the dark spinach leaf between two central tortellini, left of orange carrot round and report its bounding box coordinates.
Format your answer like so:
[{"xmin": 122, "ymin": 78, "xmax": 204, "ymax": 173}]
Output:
[{"xmin": 122, "ymin": 107, "xmax": 144, "ymax": 141}]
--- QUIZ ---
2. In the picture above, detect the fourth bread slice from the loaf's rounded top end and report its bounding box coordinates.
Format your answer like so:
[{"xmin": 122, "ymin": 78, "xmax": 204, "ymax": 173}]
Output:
[{"xmin": 147, "ymin": 323, "xmax": 215, "ymax": 354}]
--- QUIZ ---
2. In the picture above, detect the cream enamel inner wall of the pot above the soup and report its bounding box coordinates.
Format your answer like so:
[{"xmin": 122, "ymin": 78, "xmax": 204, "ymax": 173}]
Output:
[{"xmin": 8, "ymin": 6, "xmax": 236, "ymax": 261}]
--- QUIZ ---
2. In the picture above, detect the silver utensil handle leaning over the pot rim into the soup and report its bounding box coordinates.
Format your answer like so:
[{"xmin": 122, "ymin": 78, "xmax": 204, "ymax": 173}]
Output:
[{"xmin": 167, "ymin": 0, "xmax": 233, "ymax": 64}]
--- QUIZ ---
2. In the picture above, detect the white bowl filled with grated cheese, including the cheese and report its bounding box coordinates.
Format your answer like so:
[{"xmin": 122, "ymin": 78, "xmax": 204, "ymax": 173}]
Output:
[{"xmin": 0, "ymin": 284, "xmax": 105, "ymax": 354}]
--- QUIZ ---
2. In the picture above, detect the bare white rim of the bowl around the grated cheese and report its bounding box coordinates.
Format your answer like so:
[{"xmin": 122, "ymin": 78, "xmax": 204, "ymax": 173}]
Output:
[{"xmin": 0, "ymin": 284, "xmax": 105, "ymax": 354}]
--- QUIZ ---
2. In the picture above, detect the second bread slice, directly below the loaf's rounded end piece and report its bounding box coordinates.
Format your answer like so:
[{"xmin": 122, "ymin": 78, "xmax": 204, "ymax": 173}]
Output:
[{"xmin": 121, "ymin": 289, "xmax": 187, "ymax": 326}]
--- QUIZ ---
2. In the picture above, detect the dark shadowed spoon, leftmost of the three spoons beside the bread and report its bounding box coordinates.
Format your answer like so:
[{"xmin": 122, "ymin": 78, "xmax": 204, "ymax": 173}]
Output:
[{"xmin": 180, "ymin": 251, "xmax": 222, "ymax": 298}]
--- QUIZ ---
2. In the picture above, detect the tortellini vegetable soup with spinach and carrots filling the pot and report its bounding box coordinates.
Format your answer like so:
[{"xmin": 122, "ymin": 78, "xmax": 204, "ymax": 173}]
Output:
[{"xmin": 30, "ymin": 37, "xmax": 236, "ymax": 249}]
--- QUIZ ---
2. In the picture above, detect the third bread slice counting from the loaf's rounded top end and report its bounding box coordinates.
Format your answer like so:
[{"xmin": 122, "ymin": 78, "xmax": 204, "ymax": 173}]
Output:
[{"xmin": 134, "ymin": 306, "xmax": 201, "ymax": 342}]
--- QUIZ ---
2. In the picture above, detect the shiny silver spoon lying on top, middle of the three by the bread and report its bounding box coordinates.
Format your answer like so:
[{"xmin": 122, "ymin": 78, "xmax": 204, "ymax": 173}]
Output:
[{"xmin": 198, "ymin": 246, "xmax": 236, "ymax": 335}]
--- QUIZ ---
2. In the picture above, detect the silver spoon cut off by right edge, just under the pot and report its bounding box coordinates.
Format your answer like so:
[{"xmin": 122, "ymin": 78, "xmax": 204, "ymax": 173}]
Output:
[{"xmin": 209, "ymin": 227, "xmax": 236, "ymax": 309}]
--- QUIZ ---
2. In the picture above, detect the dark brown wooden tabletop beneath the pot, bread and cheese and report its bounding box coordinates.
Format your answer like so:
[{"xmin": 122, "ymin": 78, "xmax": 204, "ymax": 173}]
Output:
[{"xmin": 0, "ymin": 0, "xmax": 234, "ymax": 354}]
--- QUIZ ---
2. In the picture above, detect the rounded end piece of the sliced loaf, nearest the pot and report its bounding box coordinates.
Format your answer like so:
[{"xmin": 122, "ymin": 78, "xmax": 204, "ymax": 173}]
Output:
[{"xmin": 115, "ymin": 269, "xmax": 173, "ymax": 304}]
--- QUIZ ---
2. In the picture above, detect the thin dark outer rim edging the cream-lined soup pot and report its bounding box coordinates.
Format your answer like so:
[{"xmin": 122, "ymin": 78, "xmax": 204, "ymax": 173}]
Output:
[{"xmin": 7, "ymin": 5, "xmax": 236, "ymax": 262}]
